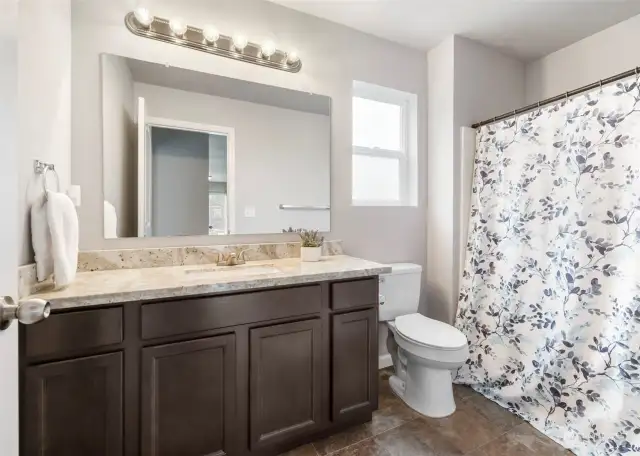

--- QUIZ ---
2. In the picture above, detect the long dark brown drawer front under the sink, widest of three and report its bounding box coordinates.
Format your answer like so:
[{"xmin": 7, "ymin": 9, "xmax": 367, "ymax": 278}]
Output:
[{"xmin": 142, "ymin": 285, "xmax": 322, "ymax": 339}]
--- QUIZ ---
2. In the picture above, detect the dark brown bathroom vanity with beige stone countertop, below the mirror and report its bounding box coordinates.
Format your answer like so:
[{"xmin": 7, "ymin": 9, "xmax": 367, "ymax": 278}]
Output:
[{"xmin": 20, "ymin": 256, "xmax": 388, "ymax": 456}]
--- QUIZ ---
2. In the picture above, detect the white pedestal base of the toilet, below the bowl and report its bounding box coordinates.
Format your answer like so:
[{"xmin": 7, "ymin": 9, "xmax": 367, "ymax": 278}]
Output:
[{"xmin": 389, "ymin": 363, "xmax": 456, "ymax": 418}]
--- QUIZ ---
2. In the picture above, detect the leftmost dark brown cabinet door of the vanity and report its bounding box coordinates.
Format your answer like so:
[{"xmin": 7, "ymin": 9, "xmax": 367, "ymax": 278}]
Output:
[{"xmin": 22, "ymin": 353, "xmax": 123, "ymax": 456}]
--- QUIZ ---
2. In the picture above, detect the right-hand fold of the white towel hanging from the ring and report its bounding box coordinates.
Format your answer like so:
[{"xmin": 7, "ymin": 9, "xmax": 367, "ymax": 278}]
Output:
[{"xmin": 46, "ymin": 192, "xmax": 79, "ymax": 288}]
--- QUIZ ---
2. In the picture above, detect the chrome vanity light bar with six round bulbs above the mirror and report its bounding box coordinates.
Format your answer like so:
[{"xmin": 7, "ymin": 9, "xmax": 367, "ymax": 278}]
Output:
[{"xmin": 124, "ymin": 8, "xmax": 302, "ymax": 73}]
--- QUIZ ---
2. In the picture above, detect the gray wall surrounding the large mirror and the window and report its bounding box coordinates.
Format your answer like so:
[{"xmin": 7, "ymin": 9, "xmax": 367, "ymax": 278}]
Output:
[{"xmin": 71, "ymin": 0, "xmax": 427, "ymax": 306}]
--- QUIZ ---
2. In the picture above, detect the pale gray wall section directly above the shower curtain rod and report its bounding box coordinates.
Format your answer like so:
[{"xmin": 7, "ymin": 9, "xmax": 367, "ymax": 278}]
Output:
[{"xmin": 526, "ymin": 15, "xmax": 640, "ymax": 103}]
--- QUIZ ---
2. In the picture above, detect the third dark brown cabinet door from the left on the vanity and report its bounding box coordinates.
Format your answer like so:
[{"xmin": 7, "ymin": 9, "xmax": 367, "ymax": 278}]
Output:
[{"xmin": 250, "ymin": 319, "xmax": 322, "ymax": 449}]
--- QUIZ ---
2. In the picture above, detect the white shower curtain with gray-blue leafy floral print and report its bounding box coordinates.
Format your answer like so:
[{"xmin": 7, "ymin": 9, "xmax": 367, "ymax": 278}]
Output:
[{"xmin": 456, "ymin": 78, "xmax": 640, "ymax": 456}]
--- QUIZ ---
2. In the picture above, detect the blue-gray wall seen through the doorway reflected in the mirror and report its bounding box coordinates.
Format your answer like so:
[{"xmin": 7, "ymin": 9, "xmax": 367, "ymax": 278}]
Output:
[{"xmin": 151, "ymin": 127, "xmax": 209, "ymax": 236}]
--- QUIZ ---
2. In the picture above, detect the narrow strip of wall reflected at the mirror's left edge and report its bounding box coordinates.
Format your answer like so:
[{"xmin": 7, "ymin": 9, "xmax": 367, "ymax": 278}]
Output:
[{"xmin": 100, "ymin": 54, "xmax": 138, "ymax": 237}]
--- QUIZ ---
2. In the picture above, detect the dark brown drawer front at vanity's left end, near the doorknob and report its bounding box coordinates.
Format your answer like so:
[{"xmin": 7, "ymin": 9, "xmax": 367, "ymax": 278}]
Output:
[{"xmin": 24, "ymin": 307, "xmax": 123, "ymax": 356}]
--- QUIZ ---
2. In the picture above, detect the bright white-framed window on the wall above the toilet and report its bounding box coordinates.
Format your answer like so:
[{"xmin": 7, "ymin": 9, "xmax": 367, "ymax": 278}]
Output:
[{"xmin": 352, "ymin": 81, "xmax": 418, "ymax": 206}]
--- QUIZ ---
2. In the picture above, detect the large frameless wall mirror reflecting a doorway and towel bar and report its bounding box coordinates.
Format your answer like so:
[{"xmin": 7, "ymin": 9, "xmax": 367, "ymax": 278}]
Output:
[{"xmin": 101, "ymin": 54, "xmax": 331, "ymax": 238}]
